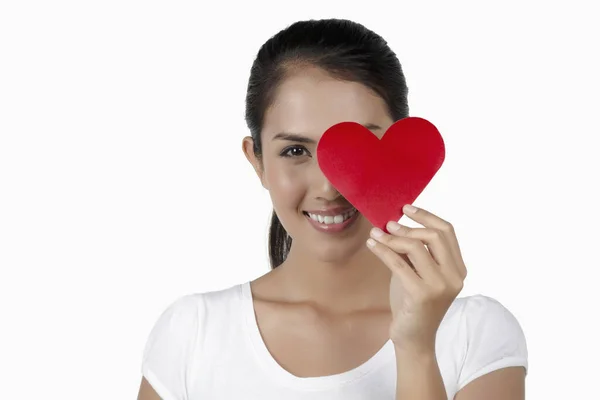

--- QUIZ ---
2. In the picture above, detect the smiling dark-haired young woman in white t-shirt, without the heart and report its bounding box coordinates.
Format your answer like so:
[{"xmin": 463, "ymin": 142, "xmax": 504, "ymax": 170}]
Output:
[{"xmin": 138, "ymin": 20, "xmax": 527, "ymax": 400}]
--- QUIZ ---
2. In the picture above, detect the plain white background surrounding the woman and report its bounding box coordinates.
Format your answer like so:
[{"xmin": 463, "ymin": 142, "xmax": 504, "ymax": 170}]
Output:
[{"xmin": 0, "ymin": 0, "xmax": 600, "ymax": 399}]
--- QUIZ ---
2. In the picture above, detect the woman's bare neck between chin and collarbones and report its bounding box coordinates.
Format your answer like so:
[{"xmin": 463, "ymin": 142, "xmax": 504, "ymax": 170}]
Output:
[{"xmin": 276, "ymin": 245, "xmax": 391, "ymax": 313}]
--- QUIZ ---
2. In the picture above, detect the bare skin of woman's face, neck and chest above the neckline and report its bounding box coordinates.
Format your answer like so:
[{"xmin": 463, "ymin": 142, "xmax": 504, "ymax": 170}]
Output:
[{"xmin": 243, "ymin": 68, "xmax": 404, "ymax": 377}]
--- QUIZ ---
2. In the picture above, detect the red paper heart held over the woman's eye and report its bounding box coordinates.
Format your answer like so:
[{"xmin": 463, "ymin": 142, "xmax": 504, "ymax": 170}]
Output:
[{"xmin": 317, "ymin": 117, "xmax": 446, "ymax": 232}]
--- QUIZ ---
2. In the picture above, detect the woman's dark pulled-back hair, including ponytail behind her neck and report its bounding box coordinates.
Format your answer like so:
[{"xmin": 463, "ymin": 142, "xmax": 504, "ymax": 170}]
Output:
[{"xmin": 246, "ymin": 19, "xmax": 408, "ymax": 268}]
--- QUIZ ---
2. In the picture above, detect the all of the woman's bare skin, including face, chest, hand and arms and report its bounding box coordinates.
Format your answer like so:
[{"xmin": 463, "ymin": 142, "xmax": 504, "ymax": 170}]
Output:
[{"xmin": 138, "ymin": 68, "xmax": 524, "ymax": 400}]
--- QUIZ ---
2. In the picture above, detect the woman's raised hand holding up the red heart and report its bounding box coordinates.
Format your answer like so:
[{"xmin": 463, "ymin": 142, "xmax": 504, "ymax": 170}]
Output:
[{"xmin": 367, "ymin": 205, "xmax": 467, "ymax": 352}]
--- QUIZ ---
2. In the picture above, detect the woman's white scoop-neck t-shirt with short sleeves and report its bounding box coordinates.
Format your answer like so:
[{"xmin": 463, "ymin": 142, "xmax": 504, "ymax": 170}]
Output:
[{"xmin": 142, "ymin": 282, "xmax": 528, "ymax": 400}]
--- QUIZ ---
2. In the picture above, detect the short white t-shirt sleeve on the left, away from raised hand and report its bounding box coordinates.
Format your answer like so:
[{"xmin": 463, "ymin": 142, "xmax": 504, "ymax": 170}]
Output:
[{"xmin": 142, "ymin": 294, "xmax": 201, "ymax": 400}]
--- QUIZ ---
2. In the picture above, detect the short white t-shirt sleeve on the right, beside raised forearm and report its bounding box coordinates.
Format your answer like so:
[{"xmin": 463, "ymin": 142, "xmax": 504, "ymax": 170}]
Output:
[{"xmin": 457, "ymin": 295, "xmax": 528, "ymax": 390}]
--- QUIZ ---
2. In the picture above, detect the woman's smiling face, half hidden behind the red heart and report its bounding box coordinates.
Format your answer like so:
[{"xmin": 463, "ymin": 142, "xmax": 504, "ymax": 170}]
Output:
[{"xmin": 244, "ymin": 68, "xmax": 393, "ymax": 262}]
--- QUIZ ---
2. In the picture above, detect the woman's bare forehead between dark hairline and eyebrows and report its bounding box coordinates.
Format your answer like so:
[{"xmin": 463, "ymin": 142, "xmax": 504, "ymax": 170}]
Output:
[{"xmin": 263, "ymin": 68, "xmax": 391, "ymax": 140}]
